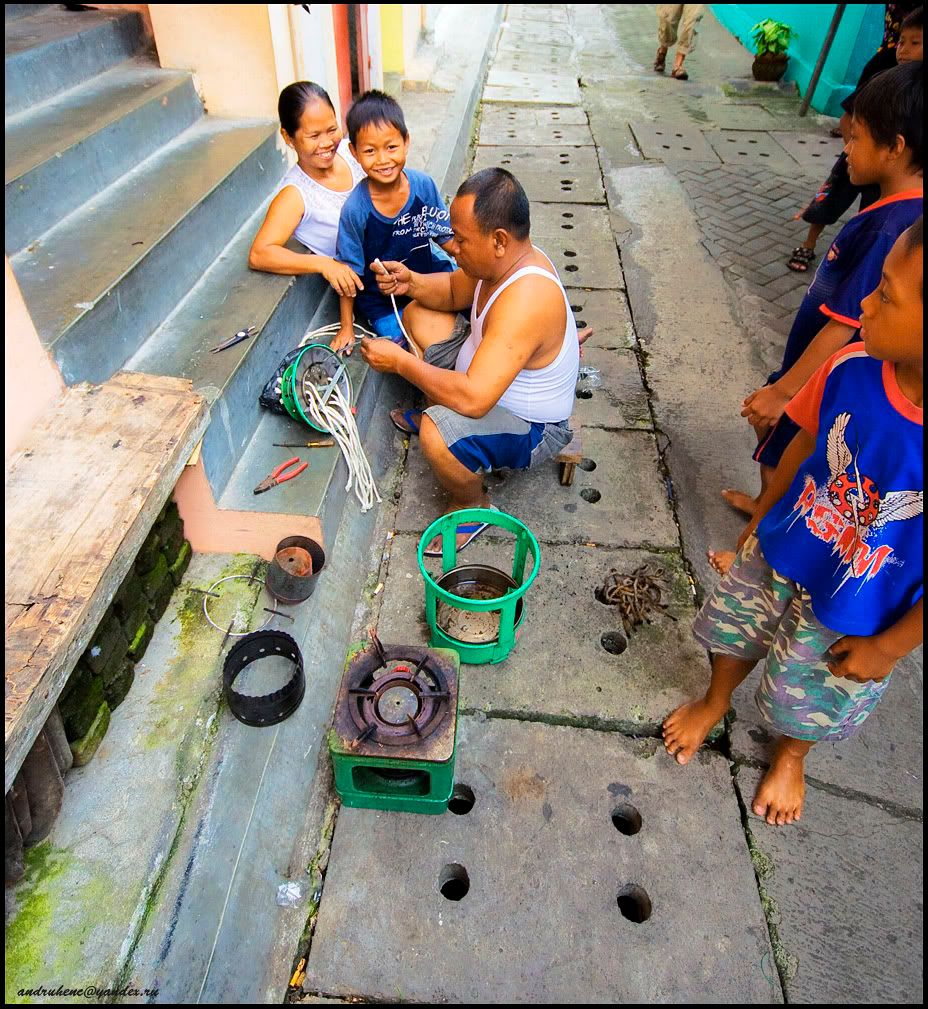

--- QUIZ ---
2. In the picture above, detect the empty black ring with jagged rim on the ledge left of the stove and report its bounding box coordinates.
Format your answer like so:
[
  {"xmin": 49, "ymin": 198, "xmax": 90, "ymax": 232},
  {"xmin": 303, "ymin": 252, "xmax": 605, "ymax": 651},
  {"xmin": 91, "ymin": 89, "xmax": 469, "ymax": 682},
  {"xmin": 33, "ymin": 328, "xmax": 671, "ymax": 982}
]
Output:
[{"xmin": 222, "ymin": 631, "xmax": 306, "ymax": 726}]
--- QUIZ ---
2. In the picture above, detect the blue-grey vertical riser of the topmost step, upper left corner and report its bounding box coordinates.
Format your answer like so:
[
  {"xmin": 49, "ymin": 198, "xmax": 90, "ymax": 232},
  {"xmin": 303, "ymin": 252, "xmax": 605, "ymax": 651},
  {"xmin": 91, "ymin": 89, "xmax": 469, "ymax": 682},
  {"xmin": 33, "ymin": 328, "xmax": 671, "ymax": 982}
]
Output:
[{"xmin": 4, "ymin": 14, "xmax": 145, "ymax": 116}]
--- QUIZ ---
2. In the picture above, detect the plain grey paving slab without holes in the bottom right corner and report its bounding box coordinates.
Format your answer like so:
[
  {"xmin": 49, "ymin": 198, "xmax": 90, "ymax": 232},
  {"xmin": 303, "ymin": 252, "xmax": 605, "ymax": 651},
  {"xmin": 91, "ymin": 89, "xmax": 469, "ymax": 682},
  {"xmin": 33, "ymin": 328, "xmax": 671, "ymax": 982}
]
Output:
[{"xmin": 735, "ymin": 768, "xmax": 923, "ymax": 1005}]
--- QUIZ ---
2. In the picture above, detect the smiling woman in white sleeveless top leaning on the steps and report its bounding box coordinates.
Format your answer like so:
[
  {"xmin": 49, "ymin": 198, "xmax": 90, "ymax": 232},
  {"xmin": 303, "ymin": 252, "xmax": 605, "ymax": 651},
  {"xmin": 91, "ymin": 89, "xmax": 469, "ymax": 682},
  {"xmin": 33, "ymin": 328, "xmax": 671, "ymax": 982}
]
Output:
[{"xmin": 248, "ymin": 81, "xmax": 365, "ymax": 298}]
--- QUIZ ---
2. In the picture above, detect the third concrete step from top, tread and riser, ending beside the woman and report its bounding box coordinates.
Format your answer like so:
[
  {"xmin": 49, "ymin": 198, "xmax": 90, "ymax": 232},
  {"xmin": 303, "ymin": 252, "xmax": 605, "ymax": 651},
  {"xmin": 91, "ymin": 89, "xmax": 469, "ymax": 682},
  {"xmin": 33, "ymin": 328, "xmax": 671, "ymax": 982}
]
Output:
[{"xmin": 11, "ymin": 118, "xmax": 284, "ymax": 383}]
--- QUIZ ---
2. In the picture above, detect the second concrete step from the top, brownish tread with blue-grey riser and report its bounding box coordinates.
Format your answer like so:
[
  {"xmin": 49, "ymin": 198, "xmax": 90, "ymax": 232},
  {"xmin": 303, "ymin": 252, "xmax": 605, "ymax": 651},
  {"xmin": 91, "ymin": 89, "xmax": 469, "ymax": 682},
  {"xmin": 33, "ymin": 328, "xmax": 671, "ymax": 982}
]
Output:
[{"xmin": 4, "ymin": 57, "xmax": 203, "ymax": 255}]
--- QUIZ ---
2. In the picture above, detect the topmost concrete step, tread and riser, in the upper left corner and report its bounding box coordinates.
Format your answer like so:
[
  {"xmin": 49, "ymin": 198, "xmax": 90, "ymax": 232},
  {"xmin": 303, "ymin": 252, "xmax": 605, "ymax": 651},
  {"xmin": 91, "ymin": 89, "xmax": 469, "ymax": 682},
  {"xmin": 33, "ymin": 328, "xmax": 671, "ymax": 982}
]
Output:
[{"xmin": 4, "ymin": 5, "xmax": 146, "ymax": 116}]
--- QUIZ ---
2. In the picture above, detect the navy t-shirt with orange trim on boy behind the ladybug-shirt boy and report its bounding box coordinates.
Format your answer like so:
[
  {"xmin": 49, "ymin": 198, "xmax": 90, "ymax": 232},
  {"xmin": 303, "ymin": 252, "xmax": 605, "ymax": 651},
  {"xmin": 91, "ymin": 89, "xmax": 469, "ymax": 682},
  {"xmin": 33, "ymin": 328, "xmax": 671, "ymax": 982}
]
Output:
[{"xmin": 768, "ymin": 190, "xmax": 923, "ymax": 383}]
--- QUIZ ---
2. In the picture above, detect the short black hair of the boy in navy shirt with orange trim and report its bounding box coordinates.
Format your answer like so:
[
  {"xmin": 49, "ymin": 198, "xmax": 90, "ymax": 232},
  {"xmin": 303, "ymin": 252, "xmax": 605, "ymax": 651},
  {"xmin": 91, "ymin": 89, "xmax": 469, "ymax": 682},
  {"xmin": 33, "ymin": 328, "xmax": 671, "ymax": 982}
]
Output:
[{"xmin": 854, "ymin": 60, "xmax": 925, "ymax": 169}]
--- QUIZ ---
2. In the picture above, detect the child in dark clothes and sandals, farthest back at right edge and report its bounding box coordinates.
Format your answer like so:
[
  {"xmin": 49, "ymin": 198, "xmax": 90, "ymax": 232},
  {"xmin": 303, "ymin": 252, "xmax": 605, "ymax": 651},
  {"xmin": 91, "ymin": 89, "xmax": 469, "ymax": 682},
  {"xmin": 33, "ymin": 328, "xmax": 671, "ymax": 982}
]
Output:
[{"xmin": 787, "ymin": 7, "xmax": 922, "ymax": 273}]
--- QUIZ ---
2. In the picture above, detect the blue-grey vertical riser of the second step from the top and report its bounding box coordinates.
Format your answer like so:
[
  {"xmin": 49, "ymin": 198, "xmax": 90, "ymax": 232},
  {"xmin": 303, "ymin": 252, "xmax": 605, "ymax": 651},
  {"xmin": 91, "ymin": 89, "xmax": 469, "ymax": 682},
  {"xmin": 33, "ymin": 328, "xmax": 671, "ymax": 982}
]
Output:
[{"xmin": 4, "ymin": 79, "xmax": 203, "ymax": 255}]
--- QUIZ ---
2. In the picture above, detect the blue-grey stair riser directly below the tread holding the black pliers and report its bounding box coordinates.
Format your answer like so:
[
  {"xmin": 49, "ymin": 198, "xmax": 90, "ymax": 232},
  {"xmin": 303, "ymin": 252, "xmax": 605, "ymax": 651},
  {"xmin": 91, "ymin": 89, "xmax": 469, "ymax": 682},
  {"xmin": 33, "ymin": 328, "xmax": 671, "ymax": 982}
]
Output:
[{"xmin": 202, "ymin": 276, "xmax": 332, "ymax": 500}]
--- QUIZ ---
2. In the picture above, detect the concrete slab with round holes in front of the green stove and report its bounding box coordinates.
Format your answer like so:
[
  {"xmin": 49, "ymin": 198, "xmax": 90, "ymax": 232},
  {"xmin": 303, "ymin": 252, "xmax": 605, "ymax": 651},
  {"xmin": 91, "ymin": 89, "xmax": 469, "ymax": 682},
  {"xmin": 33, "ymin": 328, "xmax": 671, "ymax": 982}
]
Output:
[{"xmin": 306, "ymin": 718, "xmax": 780, "ymax": 1004}]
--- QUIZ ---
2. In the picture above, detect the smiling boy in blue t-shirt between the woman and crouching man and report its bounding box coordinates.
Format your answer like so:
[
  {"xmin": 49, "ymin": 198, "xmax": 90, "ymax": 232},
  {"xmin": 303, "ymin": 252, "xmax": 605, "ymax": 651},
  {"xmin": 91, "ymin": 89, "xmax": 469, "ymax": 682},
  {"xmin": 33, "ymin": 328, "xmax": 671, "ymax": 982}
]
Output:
[{"xmin": 330, "ymin": 91, "xmax": 454, "ymax": 352}]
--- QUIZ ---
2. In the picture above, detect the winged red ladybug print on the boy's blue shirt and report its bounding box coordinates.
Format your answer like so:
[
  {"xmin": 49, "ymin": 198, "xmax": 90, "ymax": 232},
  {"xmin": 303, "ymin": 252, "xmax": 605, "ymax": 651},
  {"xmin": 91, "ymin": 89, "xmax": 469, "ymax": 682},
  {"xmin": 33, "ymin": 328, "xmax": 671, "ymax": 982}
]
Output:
[{"xmin": 789, "ymin": 413, "xmax": 923, "ymax": 596}]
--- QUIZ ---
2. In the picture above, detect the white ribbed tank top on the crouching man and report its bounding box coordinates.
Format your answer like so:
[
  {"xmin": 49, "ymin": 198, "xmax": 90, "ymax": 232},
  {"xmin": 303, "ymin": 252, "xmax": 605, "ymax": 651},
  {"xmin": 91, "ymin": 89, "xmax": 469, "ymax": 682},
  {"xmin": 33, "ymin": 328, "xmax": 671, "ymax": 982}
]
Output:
[{"xmin": 455, "ymin": 249, "xmax": 580, "ymax": 424}]
